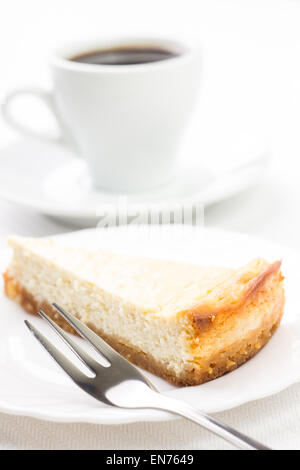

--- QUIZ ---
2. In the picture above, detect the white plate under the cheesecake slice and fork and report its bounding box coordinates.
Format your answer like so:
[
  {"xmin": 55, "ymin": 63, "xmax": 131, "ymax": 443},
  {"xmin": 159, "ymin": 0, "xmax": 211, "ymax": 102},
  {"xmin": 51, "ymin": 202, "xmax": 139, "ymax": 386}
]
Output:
[{"xmin": 0, "ymin": 226, "xmax": 300, "ymax": 424}]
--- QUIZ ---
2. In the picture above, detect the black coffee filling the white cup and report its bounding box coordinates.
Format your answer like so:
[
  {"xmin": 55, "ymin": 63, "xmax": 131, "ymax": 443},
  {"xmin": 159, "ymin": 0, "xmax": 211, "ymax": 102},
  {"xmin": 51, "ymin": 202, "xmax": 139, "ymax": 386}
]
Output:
[{"xmin": 71, "ymin": 46, "xmax": 180, "ymax": 65}]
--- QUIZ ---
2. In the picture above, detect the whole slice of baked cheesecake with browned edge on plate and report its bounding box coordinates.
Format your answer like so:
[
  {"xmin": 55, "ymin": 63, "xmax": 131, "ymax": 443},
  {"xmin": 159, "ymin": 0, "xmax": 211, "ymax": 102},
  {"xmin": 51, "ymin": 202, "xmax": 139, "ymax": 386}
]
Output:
[{"xmin": 4, "ymin": 237, "xmax": 284, "ymax": 385}]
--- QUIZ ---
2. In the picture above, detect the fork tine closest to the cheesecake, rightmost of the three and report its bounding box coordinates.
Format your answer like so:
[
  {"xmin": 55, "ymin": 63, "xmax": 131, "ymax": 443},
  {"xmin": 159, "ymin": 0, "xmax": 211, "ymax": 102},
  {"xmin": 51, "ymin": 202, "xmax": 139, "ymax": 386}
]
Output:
[{"xmin": 52, "ymin": 303, "xmax": 122, "ymax": 364}]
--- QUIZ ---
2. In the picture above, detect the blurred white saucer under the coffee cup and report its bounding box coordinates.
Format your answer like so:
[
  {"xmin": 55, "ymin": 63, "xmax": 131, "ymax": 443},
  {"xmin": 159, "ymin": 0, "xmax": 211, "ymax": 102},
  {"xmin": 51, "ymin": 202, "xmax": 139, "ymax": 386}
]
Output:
[{"xmin": 0, "ymin": 133, "xmax": 267, "ymax": 227}]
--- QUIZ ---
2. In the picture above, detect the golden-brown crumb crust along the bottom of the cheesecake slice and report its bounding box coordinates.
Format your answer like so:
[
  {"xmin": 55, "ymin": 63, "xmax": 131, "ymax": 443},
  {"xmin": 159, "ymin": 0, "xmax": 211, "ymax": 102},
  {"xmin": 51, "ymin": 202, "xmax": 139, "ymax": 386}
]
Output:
[{"xmin": 3, "ymin": 272, "xmax": 284, "ymax": 386}]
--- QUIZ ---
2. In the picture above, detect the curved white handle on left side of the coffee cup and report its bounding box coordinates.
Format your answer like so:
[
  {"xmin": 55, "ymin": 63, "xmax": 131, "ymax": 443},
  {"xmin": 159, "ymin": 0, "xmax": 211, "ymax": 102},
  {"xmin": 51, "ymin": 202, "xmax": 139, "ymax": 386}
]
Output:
[{"xmin": 1, "ymin": 88, "xmax": 75, "ymax": 149}]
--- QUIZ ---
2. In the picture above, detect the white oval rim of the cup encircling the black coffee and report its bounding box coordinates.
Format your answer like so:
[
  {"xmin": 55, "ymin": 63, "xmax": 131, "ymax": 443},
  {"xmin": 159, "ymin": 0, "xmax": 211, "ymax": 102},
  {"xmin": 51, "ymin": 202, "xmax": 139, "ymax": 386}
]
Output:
[{"xmin": 50, "ymin": 36, "xmax": 199, "ymax": 74}]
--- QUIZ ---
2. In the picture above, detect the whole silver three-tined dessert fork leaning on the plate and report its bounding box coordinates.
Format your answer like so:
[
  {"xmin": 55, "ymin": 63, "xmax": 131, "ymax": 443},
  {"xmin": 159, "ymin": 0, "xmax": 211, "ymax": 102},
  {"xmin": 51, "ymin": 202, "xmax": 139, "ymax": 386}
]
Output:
[{"xmin": 25, "ymin": 304, "xmax": 270, "ymax": 450}]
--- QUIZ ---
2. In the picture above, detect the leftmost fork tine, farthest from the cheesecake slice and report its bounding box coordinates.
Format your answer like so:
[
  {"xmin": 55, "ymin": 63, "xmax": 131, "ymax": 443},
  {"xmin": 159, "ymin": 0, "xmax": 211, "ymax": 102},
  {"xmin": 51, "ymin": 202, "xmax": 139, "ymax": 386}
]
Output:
[{"xmin": 25, "ymin": 320, "xmax": 90, "ymax": 390}]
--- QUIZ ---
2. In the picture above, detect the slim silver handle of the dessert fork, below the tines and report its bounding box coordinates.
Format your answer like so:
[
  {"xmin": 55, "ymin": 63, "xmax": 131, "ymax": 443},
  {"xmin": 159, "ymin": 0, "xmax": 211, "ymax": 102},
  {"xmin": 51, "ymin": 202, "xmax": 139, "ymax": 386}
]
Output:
[{"xmin": 155, "ymin": 396, "xmax": 271, "ymax": 450}]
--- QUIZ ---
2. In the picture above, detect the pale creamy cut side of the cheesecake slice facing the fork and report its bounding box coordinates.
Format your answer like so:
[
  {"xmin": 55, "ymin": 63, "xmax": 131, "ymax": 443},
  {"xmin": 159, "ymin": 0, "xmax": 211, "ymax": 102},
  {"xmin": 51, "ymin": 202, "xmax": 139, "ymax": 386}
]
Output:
[{"xmin": 8, "ymin": 246, "xmax": 192, "ymax": 371}]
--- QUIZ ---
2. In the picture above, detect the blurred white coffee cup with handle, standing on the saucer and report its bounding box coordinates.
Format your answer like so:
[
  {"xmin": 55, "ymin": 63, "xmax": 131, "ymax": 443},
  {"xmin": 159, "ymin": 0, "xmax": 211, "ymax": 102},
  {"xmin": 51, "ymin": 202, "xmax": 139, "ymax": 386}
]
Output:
[{"xmin": 2, "ymin": 39, "xmax": 199, "ymax": 192}]
